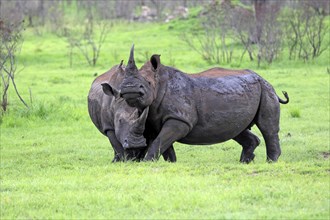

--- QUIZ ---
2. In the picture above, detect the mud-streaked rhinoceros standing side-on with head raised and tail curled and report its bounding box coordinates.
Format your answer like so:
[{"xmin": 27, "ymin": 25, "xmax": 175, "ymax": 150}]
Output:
[{"xmin": 120, "ymin": 45, "xmax": 289, "ymax": 163}]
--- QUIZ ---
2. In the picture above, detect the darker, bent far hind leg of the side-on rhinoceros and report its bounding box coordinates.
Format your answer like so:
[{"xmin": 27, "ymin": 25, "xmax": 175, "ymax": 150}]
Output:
[{"xmin": 233, "ymin": 130, "xmax": 260, "ymax": 163}]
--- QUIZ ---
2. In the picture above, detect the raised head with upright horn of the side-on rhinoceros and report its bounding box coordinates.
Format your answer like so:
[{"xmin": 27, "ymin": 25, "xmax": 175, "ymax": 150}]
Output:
[{"xmin": 120, "ymin": 45, "xmax": 157, "ymax": 111}]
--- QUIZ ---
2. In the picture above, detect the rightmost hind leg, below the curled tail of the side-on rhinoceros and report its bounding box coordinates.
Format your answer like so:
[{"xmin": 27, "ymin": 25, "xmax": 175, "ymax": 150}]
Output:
[{"xmin": 256, "ymin": 89, "xmax": 281, "ymax": 162}]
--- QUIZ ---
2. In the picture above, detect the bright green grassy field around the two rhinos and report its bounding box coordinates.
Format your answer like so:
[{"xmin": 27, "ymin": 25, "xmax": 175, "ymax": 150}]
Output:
[{"xmin": 0, "ymin": 16, "xmax": 330, "ymax": 219}]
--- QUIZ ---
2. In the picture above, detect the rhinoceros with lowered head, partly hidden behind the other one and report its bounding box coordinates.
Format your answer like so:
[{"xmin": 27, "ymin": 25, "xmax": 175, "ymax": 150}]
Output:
[{"xmin": 88, "ymin": 61, "xmax": 176, "ymax": 162}]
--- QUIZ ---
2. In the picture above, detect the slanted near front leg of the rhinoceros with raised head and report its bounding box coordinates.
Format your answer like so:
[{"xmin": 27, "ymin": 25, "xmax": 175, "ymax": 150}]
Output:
[{"xmin": 144, "ymin": 119, "xmax": 189, "ymax": 161}]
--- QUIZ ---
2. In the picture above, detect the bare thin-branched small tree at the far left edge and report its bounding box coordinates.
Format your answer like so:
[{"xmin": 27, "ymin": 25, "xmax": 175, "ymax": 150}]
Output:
[{"xmin": 0, "ymin": 19, "xmax": 28, "ymax": 111}]
